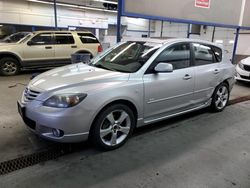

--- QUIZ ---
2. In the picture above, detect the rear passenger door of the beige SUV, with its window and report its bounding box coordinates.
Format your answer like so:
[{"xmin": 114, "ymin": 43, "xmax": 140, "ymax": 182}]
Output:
[{"xmin": 54, "ymin": 32, "xmax": 77, "ymax": 62}]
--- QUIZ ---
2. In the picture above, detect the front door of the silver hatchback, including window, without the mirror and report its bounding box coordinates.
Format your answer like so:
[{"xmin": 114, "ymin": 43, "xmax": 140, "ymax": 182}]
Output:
[{"xmin": 143, "ymin": 43, "xmax": 194, "ymax": 123}]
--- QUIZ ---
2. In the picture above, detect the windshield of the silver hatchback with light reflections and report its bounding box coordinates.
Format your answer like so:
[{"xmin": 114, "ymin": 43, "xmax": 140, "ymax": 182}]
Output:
[{"xmin": 92, "ymin": 42, "xmax": 159, "ymax": 73}]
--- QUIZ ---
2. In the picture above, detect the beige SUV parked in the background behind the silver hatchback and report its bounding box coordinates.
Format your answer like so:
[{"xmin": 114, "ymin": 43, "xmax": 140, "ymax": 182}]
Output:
[{"xmin": 0, "ymin": 31, "xmax": 102, "ymax": 76}]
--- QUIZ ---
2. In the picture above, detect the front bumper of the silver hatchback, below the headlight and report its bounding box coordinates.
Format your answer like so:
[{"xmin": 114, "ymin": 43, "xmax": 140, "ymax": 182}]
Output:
[{"xmin": 18, "ymin": 100, "xmax": 91, "ymax": 143}]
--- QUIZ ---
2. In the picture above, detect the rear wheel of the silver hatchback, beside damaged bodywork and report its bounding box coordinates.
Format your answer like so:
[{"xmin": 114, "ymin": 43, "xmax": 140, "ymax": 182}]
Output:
[{"xmin": 211, "ymin": 83, "xmax": 230, "ymax": 112}]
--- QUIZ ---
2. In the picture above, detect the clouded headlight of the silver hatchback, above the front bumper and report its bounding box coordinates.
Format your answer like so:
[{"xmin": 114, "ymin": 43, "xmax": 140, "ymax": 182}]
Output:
[{"xmin": 43, "ymin": 93, "xmax": 87, "ymax": 108}]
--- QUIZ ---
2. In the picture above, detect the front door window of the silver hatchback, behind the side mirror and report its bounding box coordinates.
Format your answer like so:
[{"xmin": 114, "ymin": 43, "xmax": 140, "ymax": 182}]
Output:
[{"xmin": 155, "ymin": 43, "xmax": 190, "ymax": 70}]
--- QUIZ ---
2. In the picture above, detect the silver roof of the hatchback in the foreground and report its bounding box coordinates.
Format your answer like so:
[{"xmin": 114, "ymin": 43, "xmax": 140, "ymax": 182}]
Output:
[{"xmin": 125, "ymin": 38, "xmax": 223, "ymax": 48}]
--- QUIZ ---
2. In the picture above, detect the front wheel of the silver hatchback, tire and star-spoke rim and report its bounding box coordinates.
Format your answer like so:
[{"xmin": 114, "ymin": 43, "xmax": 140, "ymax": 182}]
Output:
[{"xmin": 90, "ymin": 104, "xmax": 136, "ymax": 151}]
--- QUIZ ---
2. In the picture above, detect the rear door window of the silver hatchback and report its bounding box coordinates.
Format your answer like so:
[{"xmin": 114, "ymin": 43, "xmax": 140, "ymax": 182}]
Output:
[{"xmin": 193, "ymin": 43, "xmax": 216, "ymax": 66}]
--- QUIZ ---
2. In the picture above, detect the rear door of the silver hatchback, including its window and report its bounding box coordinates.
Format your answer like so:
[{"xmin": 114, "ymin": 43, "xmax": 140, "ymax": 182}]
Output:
[{"xmin": 192, "ymin": 43, "xmax": 222, "ymax": 105}]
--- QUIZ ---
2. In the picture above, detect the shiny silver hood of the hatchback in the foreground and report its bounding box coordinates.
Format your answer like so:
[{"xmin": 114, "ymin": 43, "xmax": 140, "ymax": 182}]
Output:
[{"xmin": 28, "ymin": 63, "xmax": 129, "ymax": 91}]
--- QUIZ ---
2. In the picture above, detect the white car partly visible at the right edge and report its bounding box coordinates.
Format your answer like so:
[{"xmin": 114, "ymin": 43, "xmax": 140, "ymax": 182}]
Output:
[{"xmin": 235, "ymin": 57, "xmax": 250, "ymax": 82}]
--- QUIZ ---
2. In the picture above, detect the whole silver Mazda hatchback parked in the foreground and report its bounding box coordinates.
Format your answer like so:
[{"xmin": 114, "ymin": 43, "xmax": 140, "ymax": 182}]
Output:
[{"xmin": 18, "ymin": 39, "xmax": 235, "ymax": 150}]
